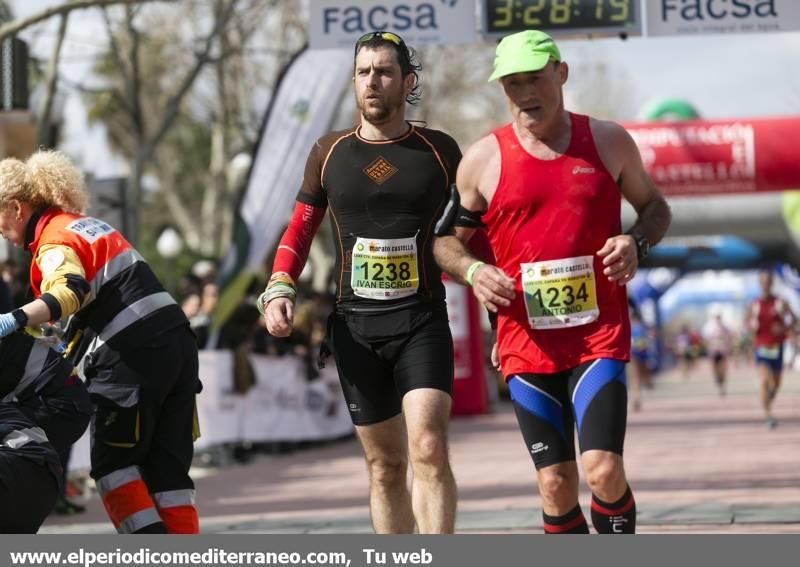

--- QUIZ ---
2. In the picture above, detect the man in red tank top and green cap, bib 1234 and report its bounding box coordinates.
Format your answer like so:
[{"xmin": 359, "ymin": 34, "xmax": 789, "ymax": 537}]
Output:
[{"xmin": 434, "ymin": 31, "xmax": 670, "ymax": 533}]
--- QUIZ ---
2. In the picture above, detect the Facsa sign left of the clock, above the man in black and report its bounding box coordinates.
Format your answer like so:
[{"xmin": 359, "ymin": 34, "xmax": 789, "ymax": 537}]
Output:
[{"xmin": 308, "ymin": 0, "xmax": 478, "ymax": 49}]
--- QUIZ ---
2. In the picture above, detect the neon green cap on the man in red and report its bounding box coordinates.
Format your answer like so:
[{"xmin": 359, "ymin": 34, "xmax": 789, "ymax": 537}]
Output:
[{"xmin": 489, "ymin": 30, "xmax": 561, "ymax": 82}]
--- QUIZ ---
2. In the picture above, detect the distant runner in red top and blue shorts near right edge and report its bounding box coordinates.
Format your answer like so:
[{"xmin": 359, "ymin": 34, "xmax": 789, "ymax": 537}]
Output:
[{"xmin": 745, "ymin": 271, "xmax": 796, "ymax": 429}]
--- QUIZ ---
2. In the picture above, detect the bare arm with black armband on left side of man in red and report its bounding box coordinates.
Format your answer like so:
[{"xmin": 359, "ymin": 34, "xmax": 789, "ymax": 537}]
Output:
[{"xmin": 433, "ymin": 136, "xmax": 514, "ymax": 313}]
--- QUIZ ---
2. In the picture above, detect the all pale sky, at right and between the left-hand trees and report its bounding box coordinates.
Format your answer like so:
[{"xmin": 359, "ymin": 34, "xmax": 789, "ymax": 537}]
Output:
[{"xmin": 10, "ymin": 0, "xmax": 800, "ymax": 176}]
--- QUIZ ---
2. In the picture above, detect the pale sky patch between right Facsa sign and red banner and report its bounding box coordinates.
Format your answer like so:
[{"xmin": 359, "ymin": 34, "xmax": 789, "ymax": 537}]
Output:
[{"xmin": 559, "ymin": 30, "xmax": 800, "ymax": 118}]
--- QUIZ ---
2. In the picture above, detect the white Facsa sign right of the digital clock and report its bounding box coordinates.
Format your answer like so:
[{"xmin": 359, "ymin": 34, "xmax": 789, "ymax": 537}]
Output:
[{"xmin": 645, "ymin": 0, "xmax": 800, "ymax": 36}]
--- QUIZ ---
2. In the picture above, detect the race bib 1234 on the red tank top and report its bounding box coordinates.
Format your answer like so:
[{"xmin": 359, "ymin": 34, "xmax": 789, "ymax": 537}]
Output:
[{"xmin": 521, "ymin": 256, "xmax": 600, "ymax": 329}]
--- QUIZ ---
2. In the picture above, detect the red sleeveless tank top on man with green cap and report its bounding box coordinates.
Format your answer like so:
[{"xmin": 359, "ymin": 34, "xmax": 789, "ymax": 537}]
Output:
[{"xmin": 483, "ymin": 113, "xmax": 630, "ymax": 378}]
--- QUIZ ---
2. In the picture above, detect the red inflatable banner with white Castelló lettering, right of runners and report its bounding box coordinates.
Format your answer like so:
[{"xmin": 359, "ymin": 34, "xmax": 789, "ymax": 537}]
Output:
[{"xmin": 623, "ymin": 116, "xmax": 800, "ymax": 196}]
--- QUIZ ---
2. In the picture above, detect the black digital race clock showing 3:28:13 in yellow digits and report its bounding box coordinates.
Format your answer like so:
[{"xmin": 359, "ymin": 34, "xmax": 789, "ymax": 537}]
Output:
[{"xmin": 483, "ymin": 0, "xmax": 642, "ymax": 36}]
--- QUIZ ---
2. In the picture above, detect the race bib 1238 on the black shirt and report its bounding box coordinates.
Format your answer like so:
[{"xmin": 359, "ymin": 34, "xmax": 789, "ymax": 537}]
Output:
[{"xmin": 350, "ymin": 236, "xmax": 419, "ymax": 300}]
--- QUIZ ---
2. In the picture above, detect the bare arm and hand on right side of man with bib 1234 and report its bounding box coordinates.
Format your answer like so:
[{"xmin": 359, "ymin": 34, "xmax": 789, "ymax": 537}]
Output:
[{"xmin": 591, "ymin": 120, "xmax": 672, "ymax": 285}]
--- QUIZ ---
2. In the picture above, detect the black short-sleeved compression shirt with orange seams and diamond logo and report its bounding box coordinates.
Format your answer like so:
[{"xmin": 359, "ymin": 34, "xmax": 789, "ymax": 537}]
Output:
[{"xmin": 297, "ymin": 126, "xmax": 461, "ymax": 308}]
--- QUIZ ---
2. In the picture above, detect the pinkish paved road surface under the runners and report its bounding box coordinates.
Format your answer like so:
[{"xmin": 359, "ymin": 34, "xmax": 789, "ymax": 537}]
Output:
[{"xmin": 41, "ymin": 363, "xmax": 800, "ymax": 533}]
